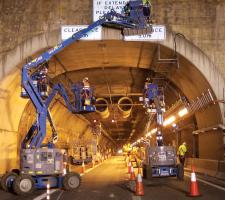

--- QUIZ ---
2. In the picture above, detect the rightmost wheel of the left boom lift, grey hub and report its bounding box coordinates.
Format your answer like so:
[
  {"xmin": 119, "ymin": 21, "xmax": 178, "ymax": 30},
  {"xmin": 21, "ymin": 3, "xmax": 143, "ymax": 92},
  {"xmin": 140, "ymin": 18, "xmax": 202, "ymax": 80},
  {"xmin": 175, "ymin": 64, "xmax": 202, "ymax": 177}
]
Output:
[{"xmin": 62, "ymin": 172, "xmax": 81, "ymax": 191}]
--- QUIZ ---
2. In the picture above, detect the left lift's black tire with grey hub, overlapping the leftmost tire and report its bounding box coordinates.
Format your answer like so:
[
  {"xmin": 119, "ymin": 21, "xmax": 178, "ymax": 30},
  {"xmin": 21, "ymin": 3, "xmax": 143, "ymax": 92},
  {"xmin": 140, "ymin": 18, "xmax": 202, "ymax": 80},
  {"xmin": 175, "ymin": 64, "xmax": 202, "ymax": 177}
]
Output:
[{"xmin": 13, "ymin": 174, "xmax": 35, "ymax": 196}]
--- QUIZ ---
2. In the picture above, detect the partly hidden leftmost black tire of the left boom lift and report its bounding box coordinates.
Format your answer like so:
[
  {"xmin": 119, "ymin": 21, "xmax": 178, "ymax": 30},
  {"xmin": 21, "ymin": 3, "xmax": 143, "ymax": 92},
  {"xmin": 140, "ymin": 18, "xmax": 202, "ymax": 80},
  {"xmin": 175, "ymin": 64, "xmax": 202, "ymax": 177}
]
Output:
[{"xmin": 1, "ymin": 172, "xmax": 18, "ymax": 192}]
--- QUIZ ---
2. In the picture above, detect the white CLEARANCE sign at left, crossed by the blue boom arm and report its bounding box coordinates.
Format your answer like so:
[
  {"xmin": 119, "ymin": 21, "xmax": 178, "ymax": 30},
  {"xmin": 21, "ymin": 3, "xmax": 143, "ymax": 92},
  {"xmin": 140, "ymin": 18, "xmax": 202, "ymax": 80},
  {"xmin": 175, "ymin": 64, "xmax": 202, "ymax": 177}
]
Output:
[{"xmin": 61, "ymin": 25, "xmax": 102, "ymax": 40}]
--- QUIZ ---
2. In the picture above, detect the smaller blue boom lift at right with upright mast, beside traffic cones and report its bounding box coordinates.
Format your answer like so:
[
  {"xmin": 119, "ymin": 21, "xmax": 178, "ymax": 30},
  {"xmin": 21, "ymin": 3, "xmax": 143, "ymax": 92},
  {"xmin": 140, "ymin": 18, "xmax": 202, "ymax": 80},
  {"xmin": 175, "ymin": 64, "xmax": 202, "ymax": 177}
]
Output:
[{"xmin": 143, "ymin": 78, "xmax": 184, "ymax": 179}]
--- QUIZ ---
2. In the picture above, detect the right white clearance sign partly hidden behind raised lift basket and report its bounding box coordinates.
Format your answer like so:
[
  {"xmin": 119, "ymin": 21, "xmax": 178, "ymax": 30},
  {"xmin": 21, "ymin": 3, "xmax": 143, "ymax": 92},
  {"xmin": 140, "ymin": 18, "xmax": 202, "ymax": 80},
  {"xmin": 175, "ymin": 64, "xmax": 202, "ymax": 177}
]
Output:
[{"xmin": 124, "ymin": 25, "xmax": 166, "ymax": 41}]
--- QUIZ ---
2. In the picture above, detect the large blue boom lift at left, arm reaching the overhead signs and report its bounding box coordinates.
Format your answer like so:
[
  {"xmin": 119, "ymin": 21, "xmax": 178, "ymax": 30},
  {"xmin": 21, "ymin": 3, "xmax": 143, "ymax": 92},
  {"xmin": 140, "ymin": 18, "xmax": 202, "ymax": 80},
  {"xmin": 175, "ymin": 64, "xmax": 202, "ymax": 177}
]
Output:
[{"xmin": 1, "ymin": 0, "xmax": 152, "ymax": 195}]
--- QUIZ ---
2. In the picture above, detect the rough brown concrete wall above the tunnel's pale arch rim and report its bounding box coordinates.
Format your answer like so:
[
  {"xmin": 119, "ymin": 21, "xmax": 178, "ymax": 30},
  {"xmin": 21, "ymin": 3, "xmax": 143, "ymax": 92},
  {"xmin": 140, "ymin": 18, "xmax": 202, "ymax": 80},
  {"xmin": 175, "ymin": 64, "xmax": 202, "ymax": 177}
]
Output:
[{"xmin": 0, "ymin": 0, "xmax": 225, "ymax": 74}]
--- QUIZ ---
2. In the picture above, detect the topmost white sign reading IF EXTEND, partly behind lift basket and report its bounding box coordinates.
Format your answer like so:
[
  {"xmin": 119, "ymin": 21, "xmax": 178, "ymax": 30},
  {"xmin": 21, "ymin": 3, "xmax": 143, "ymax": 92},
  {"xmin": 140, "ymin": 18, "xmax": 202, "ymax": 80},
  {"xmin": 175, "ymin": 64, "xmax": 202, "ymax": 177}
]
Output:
[{"xmin": 93, "ymin": 0, "xmax": 129, "ymax": 21}]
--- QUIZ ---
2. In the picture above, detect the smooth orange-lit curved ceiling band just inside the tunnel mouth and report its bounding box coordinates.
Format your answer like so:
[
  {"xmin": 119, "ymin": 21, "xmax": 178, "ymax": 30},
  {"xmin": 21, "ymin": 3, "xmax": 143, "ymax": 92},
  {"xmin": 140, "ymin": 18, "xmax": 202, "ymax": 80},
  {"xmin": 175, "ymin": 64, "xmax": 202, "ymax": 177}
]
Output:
[{"xmin": 51, "ymin": 40, "xmax": 220, "ymax": 99}]
